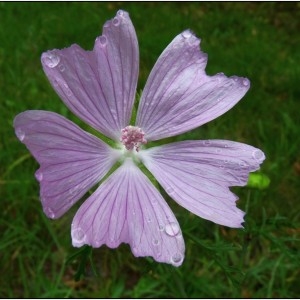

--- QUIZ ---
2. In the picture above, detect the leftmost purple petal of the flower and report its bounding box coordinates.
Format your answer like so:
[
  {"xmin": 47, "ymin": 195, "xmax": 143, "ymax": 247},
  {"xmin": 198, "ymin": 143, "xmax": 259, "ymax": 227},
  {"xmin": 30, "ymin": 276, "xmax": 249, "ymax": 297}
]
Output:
[{"xmin": 14, "ymin": 110, "xmax": 118, "ymax": 218}]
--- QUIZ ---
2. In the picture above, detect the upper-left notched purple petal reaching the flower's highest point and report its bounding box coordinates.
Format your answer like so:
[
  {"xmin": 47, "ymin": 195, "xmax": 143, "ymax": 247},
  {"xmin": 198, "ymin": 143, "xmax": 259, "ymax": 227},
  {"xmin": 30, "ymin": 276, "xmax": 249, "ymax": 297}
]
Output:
[{"xmin": 41, "ymin": 11, "xmax": 139, "ymax": 140}]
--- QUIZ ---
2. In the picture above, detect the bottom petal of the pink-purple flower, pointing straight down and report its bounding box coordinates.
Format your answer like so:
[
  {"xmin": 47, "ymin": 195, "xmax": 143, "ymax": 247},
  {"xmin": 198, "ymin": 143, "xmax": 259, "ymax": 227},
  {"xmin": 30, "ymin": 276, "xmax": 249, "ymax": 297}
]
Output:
[{"xmin": 72, "ymin": 159, "xmax": 185, "ymax": 266}]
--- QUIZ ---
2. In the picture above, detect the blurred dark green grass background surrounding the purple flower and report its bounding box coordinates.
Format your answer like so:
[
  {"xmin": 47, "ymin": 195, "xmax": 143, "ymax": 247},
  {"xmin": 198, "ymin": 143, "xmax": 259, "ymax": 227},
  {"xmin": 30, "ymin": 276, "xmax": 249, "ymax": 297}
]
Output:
[{"xmin": 0, "ymin": 2, "xmax": 300, "ymax": 298}]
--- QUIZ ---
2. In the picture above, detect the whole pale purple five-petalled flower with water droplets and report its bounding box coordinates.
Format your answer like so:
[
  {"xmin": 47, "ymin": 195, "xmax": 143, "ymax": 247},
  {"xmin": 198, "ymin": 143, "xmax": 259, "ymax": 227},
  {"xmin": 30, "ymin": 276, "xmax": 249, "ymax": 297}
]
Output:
[{"xmin": 14, "ymin": 10, "xmax": 265, "ymax": 266}]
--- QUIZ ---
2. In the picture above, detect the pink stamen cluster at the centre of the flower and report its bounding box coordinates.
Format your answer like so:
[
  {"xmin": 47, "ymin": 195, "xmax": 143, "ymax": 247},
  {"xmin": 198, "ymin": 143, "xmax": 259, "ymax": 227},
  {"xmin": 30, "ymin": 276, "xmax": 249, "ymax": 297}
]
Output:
[{"xmin": 120, "ymin": 125, "xmax": 147, "ymax": 152}]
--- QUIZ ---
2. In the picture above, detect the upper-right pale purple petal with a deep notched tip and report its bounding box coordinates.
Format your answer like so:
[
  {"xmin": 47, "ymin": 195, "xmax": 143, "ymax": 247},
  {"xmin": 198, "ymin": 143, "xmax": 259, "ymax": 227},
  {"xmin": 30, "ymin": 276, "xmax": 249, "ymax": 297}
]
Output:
[{"xmin": 136, "ymin": 31, "xmax": 250, "ymax": 140}]
